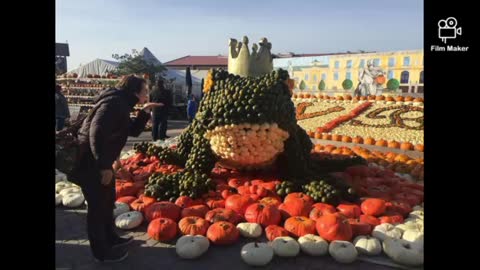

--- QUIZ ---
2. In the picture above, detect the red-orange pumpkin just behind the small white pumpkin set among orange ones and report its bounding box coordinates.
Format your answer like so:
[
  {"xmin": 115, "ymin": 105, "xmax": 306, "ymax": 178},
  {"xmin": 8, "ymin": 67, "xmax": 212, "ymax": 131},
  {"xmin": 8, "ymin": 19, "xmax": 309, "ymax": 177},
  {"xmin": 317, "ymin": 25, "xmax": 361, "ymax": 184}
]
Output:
[{"xmin": 245, "ymin": 203, "xmax": 282, "ymax": 227}]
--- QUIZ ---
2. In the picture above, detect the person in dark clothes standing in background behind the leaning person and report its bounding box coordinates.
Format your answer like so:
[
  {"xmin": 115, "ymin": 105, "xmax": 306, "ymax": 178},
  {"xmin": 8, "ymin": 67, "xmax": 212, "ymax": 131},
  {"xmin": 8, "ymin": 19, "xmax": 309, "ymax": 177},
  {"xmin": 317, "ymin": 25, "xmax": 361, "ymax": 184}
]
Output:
[{"xmin": 150, "ymin": 79, "xmax": 172, "ymax": 141}]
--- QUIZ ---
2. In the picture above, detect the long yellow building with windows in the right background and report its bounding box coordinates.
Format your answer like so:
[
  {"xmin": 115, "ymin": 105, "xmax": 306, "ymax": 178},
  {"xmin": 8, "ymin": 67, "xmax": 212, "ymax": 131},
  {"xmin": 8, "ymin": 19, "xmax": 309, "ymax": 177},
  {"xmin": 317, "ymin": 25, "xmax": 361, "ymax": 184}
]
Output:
[{"xmin": 274, "ymin": 50, "xmax": 423, "ymax": 92}]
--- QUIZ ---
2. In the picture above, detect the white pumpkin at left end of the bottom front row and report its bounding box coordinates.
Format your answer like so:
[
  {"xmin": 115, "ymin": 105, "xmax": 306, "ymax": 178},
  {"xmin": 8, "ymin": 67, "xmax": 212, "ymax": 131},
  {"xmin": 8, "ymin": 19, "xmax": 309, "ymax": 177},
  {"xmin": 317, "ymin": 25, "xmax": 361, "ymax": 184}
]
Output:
[{"xmin": 175, "ymin": 235, "xmax": 210, "ymax": 259}]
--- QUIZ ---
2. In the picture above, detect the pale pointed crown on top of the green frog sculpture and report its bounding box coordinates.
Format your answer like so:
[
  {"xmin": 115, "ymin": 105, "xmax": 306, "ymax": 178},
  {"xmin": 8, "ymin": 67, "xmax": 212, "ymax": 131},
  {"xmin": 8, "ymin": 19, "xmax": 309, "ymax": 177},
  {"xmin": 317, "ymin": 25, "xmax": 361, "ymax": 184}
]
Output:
[{"xmin": 228, "ymin": 36, "xmax": 273, "ymax": 77}]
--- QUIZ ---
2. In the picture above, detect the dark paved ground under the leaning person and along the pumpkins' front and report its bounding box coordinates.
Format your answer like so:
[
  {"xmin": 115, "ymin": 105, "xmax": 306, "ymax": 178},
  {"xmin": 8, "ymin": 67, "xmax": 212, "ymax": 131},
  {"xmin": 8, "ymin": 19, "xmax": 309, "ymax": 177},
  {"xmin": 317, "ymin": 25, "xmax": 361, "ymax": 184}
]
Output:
[{"xmin": 55, "ymin": 207, "xmax": 404, "ymax": 270}]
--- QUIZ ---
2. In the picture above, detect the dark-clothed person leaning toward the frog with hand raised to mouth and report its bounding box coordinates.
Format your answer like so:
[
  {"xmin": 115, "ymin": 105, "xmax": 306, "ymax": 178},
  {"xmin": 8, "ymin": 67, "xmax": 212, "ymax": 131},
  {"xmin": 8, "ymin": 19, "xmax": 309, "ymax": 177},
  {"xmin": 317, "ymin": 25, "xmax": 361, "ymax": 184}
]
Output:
[{"xmin": 68, "ymin": 76, "xmax": 162, "ymax": 262}]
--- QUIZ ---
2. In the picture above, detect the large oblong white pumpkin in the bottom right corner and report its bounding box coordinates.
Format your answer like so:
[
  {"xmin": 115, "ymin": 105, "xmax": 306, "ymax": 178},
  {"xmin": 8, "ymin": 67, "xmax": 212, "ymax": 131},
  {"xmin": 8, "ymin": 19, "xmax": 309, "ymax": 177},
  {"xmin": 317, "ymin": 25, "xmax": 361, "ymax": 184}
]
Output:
[{"xmin": 383, "ymin": 238, "xmax": 423, "ymax": 266}]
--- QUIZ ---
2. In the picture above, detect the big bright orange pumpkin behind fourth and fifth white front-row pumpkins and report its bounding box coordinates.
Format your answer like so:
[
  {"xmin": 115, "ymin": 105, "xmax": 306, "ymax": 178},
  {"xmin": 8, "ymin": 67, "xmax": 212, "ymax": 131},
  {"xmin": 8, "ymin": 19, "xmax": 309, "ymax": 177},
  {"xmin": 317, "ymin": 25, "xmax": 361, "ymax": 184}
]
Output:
[{"xmin": 316, "ymin": 213, "xmax": 353, "ymax": 241}]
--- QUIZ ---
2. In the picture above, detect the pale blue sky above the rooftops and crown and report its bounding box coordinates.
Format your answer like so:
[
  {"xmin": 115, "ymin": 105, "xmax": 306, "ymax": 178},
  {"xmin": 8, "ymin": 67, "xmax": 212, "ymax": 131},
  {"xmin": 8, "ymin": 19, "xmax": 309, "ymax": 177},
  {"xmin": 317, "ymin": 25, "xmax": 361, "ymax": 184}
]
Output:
[{"xmin": 55, "ymin": 0, "xmax": 423, "ymax": 70}]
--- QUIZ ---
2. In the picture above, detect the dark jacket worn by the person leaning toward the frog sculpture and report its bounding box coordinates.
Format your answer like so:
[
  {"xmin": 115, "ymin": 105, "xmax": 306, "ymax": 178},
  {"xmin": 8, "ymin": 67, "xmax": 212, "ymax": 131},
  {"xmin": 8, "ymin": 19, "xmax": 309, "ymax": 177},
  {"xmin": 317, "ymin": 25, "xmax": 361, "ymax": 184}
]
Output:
[{"xmin": 78, "ymin": 88, "xmax": 150, "ymax": 170}]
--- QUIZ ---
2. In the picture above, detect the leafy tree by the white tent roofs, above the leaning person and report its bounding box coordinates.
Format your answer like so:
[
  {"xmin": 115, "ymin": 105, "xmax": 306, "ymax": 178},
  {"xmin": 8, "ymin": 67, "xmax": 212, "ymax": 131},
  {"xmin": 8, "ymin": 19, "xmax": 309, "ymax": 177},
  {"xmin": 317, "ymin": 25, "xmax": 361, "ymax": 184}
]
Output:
[{"xmin": 112, "ymin": 50, "xmax": 167, "ymax": 84}]
